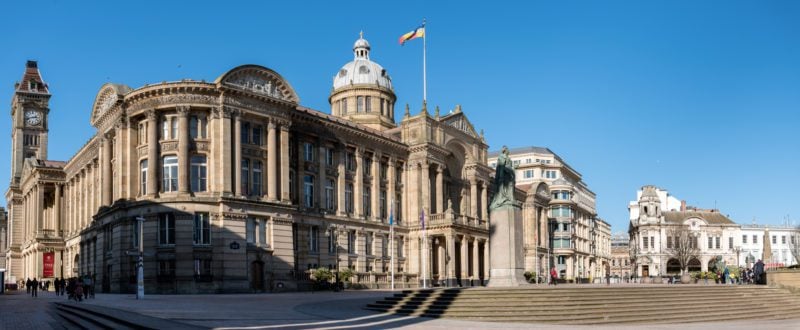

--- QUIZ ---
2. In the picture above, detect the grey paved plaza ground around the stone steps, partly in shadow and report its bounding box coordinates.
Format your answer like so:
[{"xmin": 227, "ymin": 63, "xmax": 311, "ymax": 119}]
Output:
[{"xmin": 0, "ymin": 284, "xmax": 800, "ymax": 330}]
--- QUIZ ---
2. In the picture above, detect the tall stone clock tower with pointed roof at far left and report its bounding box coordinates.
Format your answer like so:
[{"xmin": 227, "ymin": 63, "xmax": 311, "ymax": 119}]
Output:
[{"xmin": 11, "ymin": 61, "xmax": 50, "ymax": 187}]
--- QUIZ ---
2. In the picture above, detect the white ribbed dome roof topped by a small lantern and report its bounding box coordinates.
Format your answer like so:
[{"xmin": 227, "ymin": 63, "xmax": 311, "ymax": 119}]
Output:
[{"xmin": 333, "ymin": 33, "xmax": 392, "ymax": 90}]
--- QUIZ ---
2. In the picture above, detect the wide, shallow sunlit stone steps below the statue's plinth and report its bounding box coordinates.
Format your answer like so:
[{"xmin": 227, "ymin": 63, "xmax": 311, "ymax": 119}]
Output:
[{"xmin": 366, "ymin": 285, "xmax": 800, "ymax": 325}]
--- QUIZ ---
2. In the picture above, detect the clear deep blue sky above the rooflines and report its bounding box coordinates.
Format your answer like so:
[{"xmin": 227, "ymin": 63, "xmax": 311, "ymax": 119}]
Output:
[{"xmin": 0, "ymin": 0, "xmax": 800, "ymax": 232}]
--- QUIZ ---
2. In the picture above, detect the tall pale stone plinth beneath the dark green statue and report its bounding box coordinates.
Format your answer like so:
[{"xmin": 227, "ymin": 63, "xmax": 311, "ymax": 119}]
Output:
[{"xmin": 488, "ymin": 206, "xmax": 526, "ymax": 287}]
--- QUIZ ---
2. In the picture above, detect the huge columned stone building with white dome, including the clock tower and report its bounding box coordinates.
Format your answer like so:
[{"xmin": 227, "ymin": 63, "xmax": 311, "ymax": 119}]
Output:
[{"xmin": 5, "ymin": 38, "xmax": 494, "ymax": 293}]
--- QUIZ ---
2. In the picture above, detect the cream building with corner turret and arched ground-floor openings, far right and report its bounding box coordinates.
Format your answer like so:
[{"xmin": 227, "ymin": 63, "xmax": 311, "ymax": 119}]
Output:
[{"xmin": 628, "ymin": 186, "xmax": 740, "ymax": 277}]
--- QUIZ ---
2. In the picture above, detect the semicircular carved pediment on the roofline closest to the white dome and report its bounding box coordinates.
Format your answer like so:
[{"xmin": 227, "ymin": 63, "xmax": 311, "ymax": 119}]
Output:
[{"xmin": 216, "ymin": 65, "xmax": 300, "ymax": 104}]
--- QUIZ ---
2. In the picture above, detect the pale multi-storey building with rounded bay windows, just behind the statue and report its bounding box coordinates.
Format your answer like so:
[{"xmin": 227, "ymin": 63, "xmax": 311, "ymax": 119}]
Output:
[{"xmin": 488, "ymin": 147, "xmax": 611, "ymax": 279}]
